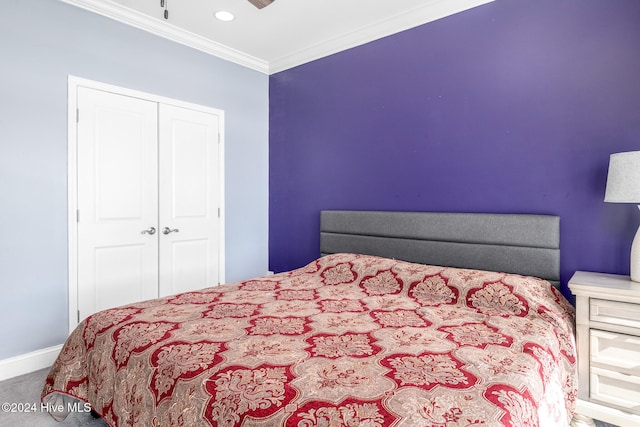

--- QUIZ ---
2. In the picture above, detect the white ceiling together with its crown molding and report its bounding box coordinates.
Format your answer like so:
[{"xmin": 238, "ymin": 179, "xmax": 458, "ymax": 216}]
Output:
[{"xmin": 62, "ymin": 0, "xmax": 493, "ymax": 74}]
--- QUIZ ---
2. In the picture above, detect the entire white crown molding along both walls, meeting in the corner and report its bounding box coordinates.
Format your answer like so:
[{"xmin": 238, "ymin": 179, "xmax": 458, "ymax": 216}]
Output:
[{"xmin": 61, "ymin": 0, "xmax": 494, "ymax": 74}]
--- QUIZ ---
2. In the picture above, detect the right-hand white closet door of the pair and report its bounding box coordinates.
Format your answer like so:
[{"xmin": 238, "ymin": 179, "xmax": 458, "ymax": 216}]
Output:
[{"xmin": 159, "ymin": 104, "xmax": 220, "ymax": 296}]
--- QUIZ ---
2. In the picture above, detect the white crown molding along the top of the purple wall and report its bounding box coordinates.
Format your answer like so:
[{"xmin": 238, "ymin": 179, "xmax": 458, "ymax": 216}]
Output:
[{"xmin": 269, "ymin": 0, "xmax": 494, "ymax": 74}]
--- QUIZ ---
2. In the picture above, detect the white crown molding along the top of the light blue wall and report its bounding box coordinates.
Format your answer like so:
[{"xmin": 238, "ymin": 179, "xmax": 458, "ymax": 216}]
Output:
[{"xmin": 61, "ymin": 0, "xmax": 269, "ymax": 73}]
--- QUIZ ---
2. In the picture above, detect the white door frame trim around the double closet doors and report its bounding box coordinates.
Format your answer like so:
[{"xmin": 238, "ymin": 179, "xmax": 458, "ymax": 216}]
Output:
[{"xmin": 67, "ymin": 75, "xmax": 225, "ymax": 333}]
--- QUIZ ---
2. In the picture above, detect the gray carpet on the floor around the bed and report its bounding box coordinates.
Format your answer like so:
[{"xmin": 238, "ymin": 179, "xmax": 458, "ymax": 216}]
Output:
[{"xmin": 0, "ymin": 368, "xmax": 615, "ymax": 427}]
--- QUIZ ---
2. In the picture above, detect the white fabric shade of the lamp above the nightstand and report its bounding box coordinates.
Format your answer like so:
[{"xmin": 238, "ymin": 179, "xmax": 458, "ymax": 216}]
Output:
[{"xmin": 604, "ymin": 151, "xmax": 640, "ymax": 203}]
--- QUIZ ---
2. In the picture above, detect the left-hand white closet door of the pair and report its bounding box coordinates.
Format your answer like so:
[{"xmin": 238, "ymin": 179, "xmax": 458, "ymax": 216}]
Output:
[{"xmin": 77, "ymin": 87, "xmax": 159, "ymax": 320}]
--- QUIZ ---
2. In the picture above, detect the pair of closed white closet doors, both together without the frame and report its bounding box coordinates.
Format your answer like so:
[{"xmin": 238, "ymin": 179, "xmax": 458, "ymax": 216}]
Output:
[{"xmin": 76, "ymin": 87, "xmax": 223, "ymax": 322}]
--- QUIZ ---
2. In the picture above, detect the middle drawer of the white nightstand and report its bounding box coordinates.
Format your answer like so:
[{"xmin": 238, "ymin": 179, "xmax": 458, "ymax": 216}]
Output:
[{"xmin": 589, "ymin": 329, "xmax": 640, "ymax": 377}]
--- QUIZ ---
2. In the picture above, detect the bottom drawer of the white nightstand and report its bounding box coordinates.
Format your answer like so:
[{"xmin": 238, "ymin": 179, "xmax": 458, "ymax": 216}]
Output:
[{"xmin": 590, "ymin": 367, "xmax": 640, "ymax": 414}]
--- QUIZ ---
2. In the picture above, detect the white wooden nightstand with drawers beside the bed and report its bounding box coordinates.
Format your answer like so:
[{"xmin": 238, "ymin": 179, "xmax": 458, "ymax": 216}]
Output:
[{"xmin": 569, "ymin": 271, "xmax": 640, "ymax": 427}]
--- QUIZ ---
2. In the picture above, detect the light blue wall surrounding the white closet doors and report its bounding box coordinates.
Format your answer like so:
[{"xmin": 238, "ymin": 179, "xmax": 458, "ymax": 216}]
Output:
[{"xmin": 0, "ymin": 0, "xmax": 269, "ymax": 360}]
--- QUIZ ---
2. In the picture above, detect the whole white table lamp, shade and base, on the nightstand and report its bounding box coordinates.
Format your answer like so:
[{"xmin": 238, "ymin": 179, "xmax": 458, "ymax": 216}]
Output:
[{"xmin": 604, "ymin": 151, "xmax": 640, "ymax": 282}]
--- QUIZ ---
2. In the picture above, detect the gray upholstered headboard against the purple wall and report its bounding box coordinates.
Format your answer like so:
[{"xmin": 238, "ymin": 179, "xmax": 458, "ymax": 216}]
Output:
[{"xmin": 320, "ymin": 210, "xmax": 560, "ymax": 286}]
